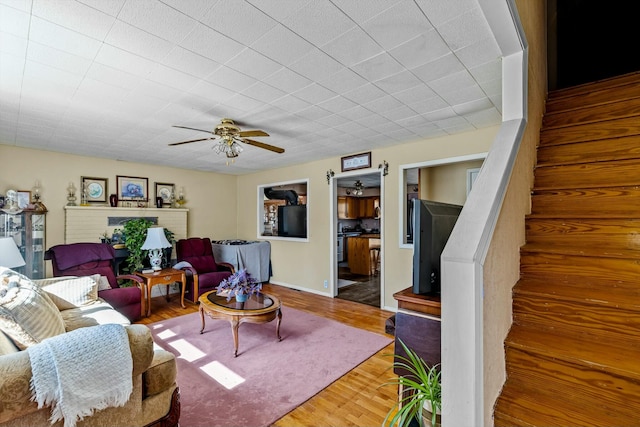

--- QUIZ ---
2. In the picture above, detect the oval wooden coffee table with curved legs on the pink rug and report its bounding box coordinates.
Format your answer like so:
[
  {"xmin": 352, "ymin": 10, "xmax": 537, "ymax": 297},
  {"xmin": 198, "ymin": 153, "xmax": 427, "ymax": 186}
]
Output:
[{"xmin": 198, "ymin": 291, "xmax": 282, "ymax": 357}]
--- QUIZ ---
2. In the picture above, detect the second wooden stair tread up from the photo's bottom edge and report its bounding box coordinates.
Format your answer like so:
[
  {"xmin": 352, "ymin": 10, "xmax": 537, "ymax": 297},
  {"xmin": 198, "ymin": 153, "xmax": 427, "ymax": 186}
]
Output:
[{"xmin": 505, "ymin": 325, "xmax": 640, "ymax": 381}]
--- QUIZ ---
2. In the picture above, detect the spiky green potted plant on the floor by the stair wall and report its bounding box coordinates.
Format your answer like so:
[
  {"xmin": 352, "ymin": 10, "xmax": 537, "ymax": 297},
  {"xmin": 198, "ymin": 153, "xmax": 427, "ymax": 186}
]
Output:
[{"xmin": 382, "ymin": 340, "xmax": 442, "ymax": 427}]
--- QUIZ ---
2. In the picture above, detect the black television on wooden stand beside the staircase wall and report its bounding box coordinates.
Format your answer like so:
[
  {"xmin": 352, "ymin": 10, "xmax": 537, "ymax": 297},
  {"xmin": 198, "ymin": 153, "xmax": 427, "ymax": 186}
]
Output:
[{"xmin": 412, "ymin": 199, "xmax": 462, "ymax": 295}]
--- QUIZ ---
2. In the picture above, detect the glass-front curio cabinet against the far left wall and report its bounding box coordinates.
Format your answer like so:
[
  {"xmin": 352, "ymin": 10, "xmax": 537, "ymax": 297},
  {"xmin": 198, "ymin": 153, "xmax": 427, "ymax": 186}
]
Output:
[{"xmin": 0, "ymin": 210, "xmax": 46, "ymax": 279}]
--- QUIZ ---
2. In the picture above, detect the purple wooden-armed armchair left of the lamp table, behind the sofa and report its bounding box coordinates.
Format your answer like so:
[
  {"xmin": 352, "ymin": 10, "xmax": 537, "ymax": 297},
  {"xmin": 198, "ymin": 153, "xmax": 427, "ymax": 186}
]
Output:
[{"xmin": 47, "ymin": 243, "xmax": 144, "ymax": 321}]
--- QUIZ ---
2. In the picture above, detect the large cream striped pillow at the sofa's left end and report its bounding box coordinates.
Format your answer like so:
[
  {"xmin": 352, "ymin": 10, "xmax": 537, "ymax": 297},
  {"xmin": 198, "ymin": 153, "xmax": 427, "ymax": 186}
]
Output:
[{"xmin": 0, "ymin": 267, "xmax": 65, "ymax": 350}]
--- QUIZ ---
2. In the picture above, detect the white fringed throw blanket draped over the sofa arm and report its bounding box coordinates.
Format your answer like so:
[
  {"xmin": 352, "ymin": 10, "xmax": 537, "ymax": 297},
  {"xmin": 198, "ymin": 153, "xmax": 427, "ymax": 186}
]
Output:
[{"xmin": 27, "ymin": 324, "xmax": 133, "ymax": 427}]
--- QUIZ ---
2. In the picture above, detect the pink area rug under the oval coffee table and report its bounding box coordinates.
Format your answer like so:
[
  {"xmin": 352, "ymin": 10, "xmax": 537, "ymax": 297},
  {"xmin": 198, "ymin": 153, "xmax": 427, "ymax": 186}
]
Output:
[{"xmin": 149, "ymin": 307, "xmax": 391, "ymax": 427}]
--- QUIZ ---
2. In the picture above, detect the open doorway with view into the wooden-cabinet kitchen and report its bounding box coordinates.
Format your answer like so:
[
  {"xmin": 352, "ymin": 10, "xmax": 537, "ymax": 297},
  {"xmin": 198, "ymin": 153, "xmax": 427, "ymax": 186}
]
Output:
[{"xmin": 331, "ymin": 171, "xmax": 384, "ymax": 308}]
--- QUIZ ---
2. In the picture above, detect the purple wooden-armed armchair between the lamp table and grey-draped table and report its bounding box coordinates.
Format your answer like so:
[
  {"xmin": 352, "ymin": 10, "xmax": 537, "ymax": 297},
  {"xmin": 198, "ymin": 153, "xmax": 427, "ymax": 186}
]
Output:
[{"xmin": 176, "ymin": 237, "xmax": 234, "ymax": 302}]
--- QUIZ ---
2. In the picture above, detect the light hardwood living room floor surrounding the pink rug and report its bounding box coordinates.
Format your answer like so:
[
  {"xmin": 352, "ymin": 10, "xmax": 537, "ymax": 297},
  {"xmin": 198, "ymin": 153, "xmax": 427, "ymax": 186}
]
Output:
[{"xmin": 137, "ymin": 284, "xmax": 397, "ymax": 427}]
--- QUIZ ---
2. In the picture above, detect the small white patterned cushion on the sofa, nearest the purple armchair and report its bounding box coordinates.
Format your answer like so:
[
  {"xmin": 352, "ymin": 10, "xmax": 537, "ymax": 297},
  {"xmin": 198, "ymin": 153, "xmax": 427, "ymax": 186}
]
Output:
[{"xmin": 34, "ymin": 275, "xmax": 100, "ymax": 310}]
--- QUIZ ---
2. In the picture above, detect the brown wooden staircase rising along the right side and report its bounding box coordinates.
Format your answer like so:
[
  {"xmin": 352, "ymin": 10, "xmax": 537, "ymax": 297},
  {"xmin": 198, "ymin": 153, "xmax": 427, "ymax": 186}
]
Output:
[{"xmin": 494, "ymin": 73, "xmax": 640, "ymax": 426}]
